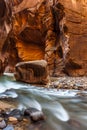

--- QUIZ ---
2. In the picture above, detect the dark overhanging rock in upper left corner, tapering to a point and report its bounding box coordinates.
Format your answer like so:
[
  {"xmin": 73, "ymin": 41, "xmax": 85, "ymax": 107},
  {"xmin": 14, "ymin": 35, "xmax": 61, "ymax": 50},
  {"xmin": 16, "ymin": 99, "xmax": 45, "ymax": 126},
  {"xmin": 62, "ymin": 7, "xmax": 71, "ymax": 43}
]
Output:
[{"xmin": 0, "ymin": 0, "xmax": 12, "ymax": 51}]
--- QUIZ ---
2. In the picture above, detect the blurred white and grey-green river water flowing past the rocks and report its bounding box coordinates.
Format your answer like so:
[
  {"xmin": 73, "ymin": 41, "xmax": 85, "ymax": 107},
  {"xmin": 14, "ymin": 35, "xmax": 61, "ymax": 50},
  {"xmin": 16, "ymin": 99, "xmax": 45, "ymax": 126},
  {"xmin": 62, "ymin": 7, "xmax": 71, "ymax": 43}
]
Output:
[{"xmin": 0, "ymin": 74, "xmax": 87, "ymax": 130}]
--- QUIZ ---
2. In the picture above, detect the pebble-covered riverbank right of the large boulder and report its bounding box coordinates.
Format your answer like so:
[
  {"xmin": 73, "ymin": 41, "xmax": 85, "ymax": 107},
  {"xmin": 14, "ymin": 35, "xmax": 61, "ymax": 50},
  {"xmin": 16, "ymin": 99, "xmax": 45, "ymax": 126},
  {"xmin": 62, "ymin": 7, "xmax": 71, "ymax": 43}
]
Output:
[{"xmin": 51, "ymin": 76, "xmax": 87, "ymax": 91}]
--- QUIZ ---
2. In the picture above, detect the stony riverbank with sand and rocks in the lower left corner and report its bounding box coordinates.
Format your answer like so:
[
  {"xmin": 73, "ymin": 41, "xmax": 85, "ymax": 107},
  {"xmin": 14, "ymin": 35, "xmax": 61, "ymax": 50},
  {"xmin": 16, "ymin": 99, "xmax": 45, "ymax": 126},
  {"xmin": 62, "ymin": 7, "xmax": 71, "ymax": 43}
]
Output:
[{"xmin": 0, "ymin": 99, "xmax": 45, "ymax": 130}]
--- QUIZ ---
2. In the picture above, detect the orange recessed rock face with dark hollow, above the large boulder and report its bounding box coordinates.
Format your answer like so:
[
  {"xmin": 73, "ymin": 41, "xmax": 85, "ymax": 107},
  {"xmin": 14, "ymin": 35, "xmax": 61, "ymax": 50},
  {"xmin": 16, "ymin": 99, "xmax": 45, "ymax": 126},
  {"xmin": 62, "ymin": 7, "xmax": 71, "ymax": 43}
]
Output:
[{"xmin": 13, "ymin": 0, "xmax": 46, "ymax": 61}]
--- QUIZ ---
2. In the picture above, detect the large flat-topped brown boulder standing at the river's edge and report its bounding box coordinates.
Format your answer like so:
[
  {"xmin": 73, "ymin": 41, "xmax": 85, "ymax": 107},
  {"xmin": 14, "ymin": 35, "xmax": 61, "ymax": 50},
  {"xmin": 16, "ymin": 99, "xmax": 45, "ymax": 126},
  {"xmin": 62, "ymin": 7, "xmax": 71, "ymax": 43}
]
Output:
[{"xmin": 14, "ymin": 60, "xmax": 49, "ymax": 84}]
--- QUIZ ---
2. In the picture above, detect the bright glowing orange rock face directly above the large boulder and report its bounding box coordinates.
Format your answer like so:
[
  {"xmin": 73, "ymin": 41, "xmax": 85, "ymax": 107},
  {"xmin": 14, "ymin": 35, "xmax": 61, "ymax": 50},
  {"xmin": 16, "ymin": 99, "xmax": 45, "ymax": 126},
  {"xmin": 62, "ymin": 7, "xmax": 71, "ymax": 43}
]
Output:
[{"xmin": 16, "ymin": 42, "xmax": 44, "ymax": 61}]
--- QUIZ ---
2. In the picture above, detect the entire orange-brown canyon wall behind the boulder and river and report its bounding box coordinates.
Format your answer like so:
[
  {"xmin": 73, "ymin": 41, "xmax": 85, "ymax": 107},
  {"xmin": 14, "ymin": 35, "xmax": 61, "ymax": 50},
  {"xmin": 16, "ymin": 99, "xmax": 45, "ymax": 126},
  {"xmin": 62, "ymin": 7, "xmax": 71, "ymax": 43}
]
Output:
[{"xmin": 0, "ymin": 0, "xmax": 87, "ymax": 76}]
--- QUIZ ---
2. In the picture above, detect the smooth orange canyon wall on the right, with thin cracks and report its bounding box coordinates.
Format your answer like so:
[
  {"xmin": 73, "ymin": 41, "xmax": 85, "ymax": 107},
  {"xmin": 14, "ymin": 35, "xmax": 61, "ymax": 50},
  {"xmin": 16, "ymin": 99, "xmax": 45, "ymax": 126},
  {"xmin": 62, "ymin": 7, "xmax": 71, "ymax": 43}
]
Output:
[{"xmin": 59, "ymin": 0, "xmax": 87, "ymax": 76}]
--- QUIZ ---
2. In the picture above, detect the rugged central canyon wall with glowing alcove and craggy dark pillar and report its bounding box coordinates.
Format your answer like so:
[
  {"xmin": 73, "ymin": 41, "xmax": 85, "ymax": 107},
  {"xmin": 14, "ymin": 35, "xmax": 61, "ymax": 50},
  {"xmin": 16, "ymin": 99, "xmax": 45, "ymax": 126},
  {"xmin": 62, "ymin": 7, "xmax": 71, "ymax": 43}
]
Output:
[{"xmin": 2, "ymin": 0, "xmax": 69, "ymax": 76}]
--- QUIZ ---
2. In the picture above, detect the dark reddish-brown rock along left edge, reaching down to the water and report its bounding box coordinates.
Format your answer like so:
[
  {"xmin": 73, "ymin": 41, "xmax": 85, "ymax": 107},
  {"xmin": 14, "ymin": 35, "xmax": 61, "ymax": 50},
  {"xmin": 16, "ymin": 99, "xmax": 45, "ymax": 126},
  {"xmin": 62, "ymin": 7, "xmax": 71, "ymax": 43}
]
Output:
[{"xmin": 0, "ymin": 0, "xmax": 12, "ymax": 74}]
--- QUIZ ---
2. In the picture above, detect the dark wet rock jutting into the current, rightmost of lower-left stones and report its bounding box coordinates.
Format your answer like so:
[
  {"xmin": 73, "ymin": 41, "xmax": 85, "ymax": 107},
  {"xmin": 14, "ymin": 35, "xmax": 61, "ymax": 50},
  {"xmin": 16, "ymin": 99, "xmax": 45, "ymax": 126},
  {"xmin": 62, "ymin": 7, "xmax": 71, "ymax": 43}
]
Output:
[{"xmin": 24, "ymin": 108, "xmax": 45, "ymax": 122}]
